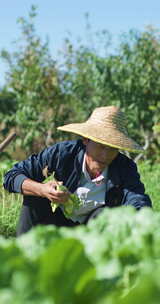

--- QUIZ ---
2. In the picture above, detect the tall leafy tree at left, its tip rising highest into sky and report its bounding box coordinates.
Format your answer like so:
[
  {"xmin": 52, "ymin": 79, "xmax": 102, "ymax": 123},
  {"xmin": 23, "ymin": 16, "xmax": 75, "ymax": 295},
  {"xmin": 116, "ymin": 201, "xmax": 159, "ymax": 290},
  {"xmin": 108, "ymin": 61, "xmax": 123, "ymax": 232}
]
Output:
[{"xmin": 1, "ymin": 6, "xmax": 73, "ymax": 152}]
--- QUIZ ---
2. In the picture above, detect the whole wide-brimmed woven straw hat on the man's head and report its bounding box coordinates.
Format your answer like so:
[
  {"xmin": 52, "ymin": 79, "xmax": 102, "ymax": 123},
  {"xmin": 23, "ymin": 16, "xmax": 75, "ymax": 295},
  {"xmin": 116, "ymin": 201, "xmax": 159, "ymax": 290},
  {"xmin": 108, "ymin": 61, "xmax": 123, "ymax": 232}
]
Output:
[{"xmin": 58, "ymin": 106, "xmax": 143, "ymax": 153}]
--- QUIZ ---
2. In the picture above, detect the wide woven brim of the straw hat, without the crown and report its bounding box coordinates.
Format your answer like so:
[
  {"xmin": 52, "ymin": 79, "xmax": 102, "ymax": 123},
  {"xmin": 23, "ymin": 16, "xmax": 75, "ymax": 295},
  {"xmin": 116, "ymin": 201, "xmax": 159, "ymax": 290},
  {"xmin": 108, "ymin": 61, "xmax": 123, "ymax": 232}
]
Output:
[{"xmin": 57, "ymin": 122, "xmax": 144, "ymax": 153}]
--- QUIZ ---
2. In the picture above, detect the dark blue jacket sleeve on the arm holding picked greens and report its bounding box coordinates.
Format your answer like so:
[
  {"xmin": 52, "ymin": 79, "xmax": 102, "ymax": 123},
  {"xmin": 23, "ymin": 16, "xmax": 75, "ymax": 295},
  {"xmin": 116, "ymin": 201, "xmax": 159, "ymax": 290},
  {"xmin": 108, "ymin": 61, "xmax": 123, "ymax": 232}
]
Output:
[{"xmin": 3, "ymin": 144, "xmax": 59, "ymax": 193}]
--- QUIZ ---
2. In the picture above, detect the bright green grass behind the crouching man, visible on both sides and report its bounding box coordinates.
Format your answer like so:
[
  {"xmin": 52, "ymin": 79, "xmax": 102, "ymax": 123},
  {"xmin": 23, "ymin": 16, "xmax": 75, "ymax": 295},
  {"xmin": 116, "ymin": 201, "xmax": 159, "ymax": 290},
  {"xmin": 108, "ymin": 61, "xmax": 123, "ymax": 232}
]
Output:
[{"xmin": 0, "ymin": 162, "xmax": 160, "ymax": 238}]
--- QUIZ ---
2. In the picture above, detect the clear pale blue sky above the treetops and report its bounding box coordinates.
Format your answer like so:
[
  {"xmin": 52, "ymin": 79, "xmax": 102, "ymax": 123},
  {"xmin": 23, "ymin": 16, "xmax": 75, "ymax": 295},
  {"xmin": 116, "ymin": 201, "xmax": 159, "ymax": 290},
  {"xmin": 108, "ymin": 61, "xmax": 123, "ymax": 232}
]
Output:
[{"xmin": 0, "ymin": 0, "xmax": 160, "ymax": 86}]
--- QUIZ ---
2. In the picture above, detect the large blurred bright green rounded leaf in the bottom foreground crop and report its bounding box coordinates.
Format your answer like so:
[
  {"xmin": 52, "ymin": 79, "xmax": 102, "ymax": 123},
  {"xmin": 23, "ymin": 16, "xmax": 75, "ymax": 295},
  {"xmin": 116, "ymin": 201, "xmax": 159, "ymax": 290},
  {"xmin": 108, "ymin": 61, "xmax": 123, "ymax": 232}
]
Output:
[{"xmin": 39, "ymin": 239, "xmax": 95, "ymax": 304}]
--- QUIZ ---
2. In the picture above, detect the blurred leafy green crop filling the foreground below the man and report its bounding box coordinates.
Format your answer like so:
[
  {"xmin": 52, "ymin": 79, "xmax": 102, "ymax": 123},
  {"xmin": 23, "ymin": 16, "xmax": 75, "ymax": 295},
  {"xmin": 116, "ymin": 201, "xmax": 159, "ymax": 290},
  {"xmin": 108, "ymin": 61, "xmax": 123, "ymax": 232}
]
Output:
[{"xmin": 0, "ymin": 207, "xmax": 160, "ymax": 304}]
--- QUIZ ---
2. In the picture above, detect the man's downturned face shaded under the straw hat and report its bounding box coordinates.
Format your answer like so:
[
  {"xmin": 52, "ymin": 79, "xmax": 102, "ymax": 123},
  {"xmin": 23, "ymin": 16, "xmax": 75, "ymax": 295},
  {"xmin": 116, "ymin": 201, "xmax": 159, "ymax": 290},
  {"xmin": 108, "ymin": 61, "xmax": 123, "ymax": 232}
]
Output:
[{"xmin": 83, "ymin": 139, "xmax": 118, "ymax": 175}]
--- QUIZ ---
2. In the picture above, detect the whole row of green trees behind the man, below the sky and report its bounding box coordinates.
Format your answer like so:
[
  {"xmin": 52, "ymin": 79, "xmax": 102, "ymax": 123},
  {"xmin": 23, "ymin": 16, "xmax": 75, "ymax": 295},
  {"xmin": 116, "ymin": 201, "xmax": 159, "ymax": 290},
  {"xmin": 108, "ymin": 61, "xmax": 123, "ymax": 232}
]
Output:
[{"xmin": 1, "ymin": 6, "xmax": 160, "ymax": 163}]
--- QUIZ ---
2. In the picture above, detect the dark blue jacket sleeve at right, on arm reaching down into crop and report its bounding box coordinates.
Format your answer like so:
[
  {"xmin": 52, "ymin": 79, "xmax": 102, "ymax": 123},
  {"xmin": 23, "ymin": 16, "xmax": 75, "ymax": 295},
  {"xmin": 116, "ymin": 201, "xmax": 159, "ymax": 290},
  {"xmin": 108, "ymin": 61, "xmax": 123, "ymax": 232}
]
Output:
[{"xmin": 121, "ymin": 157, "xmax": 152, "ymax": 210}]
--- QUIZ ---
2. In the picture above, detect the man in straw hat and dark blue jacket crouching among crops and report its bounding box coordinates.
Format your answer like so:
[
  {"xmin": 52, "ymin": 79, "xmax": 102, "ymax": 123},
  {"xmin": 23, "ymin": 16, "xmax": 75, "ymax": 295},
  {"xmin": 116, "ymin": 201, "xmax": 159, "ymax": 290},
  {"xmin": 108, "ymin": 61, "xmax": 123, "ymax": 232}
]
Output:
[{"xmin": 4, "ymin": 106, "xmax": 152, "ymax": 235}]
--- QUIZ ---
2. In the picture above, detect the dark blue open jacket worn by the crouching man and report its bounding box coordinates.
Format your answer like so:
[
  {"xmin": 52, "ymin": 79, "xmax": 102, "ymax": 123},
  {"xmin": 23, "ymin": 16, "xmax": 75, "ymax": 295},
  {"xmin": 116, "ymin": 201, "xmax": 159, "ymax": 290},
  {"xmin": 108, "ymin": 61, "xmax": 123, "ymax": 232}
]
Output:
[{"xmin": 4, "ymin": 140, "xmax": 152, "ymax": 209}]
